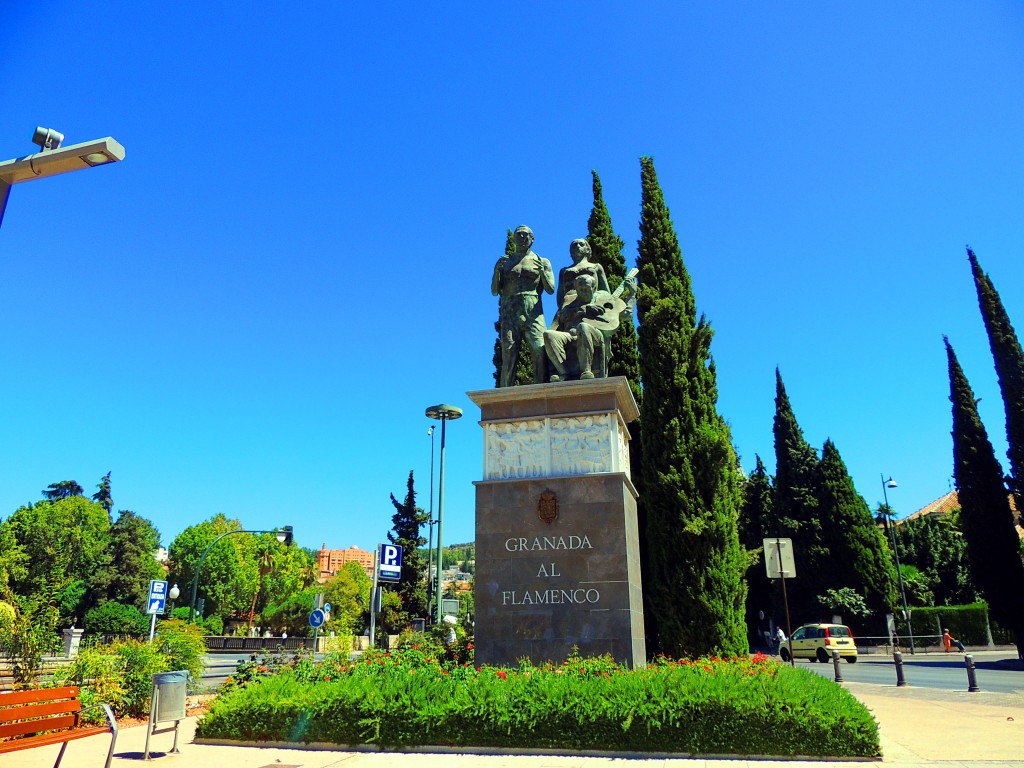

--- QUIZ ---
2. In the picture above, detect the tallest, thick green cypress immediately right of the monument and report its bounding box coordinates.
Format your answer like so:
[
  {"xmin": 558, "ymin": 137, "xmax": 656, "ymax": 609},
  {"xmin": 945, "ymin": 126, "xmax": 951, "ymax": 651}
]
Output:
[{"xmin": 637, "ymin": 158, "xmax": 748, "ymax": 656}]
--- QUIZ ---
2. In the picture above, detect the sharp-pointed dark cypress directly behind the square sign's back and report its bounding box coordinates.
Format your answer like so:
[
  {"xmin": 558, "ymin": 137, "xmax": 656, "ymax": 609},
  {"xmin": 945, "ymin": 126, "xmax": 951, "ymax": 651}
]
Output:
[{"xmin": 773, "ymin": 369, "xmax": 828, "ymax": 625}]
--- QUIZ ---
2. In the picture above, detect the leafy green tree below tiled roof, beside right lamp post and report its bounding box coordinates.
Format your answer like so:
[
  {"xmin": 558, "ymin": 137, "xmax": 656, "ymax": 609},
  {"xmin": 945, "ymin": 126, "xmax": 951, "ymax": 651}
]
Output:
[{"xmin": 892, "ymin": 505, "xmax": 981, "ymax": 605}]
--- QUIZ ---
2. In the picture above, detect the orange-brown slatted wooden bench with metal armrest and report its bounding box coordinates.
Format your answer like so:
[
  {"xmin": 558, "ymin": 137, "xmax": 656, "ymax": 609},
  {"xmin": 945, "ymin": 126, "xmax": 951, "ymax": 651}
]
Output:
[{"xmin": 0, "ymin": 686, "xmax": 118, "ymax": 768}]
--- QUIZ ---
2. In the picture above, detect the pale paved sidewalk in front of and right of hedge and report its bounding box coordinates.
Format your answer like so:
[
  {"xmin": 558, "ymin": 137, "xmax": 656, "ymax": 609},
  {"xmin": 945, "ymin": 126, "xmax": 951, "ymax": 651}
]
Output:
[{"xmin": 8, "ymin": 683, "xmax": 1024, "ymax": 768}]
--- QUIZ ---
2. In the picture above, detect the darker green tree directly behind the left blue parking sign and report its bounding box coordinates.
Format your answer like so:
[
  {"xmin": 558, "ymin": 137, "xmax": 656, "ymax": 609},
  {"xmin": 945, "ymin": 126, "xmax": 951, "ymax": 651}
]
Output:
[{"xmin": 89, "ymin": 512, "xmax": 164, "ymax": 607}]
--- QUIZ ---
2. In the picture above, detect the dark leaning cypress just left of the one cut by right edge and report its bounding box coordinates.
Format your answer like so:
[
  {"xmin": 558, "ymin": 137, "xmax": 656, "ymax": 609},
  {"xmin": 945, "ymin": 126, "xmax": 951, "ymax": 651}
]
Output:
[{"xmin": 943, "ymin": 339, "xmax": 1024, "ymax": 657}]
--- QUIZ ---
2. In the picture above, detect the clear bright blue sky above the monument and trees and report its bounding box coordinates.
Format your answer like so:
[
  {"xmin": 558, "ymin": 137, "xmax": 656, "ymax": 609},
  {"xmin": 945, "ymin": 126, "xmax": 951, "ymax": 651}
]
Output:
[{"xmin": 0, "ymin": 6, "xmax": 1024, "ymax": 548}]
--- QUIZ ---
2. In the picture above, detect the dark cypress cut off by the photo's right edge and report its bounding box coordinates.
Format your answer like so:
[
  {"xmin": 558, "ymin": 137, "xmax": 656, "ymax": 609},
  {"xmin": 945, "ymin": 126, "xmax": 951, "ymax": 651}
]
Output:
[{"xmin": 967, "ymin": 246, "xmax": 1024, "ymax": 510}]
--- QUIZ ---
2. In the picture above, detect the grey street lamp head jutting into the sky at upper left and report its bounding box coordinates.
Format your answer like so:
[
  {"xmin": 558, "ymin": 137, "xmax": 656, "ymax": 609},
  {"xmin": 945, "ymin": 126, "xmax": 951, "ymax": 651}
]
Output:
[{"xmin": 0, "ymin": 127, "xmax": 125, "ymax": 224}]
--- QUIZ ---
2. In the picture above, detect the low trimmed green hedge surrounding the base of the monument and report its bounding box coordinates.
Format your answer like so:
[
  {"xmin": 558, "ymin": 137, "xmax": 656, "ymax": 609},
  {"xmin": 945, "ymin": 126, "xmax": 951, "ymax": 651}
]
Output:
[{"xmin": 197, "ymin": 654, "xmax": 881, "ymax": 758}]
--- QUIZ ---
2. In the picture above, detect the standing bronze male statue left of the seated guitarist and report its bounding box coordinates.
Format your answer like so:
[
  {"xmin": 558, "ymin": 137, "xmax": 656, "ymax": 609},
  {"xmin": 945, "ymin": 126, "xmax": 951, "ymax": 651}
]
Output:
[{"xmin": 490, "ymin": 225, "xmax": 555, "ymax": 387}]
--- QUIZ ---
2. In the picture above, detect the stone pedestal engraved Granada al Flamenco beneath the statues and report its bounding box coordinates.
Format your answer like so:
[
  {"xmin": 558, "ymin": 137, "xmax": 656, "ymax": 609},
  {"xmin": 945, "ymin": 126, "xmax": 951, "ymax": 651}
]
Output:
[{"xmin": 468, "ymin": 377, "xmax": 646, "ymax": 667}]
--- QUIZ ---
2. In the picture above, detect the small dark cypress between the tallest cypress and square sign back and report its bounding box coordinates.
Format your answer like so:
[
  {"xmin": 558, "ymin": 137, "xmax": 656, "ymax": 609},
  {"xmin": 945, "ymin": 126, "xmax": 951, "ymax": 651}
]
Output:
[{"xmin": 738, "ymin": 456, "xmax": 782, "ymax": 645}]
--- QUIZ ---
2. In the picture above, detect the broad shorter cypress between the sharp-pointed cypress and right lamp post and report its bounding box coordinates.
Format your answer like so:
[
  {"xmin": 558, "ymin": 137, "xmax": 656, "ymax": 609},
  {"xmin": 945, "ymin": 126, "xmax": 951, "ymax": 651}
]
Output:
[{"xmin": 818, "ymin": 440, "xmax": 897, "ymax": 614}]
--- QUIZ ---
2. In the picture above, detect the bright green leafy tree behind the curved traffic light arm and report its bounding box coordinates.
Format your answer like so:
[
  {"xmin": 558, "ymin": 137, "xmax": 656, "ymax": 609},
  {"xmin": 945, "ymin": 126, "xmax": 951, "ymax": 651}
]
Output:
[{"xmin": 168, "ymin": 514, "xmax": 259, "ymax": 618}]
